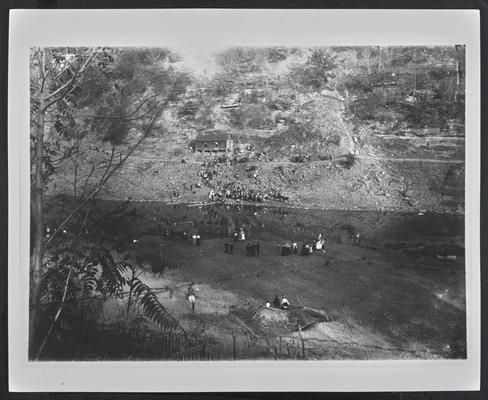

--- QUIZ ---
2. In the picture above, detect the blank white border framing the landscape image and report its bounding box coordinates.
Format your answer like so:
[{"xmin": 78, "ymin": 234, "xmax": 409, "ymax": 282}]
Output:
[{"xmin": 8, "ymin": 9, "xmax": 480, "ymax": 392}]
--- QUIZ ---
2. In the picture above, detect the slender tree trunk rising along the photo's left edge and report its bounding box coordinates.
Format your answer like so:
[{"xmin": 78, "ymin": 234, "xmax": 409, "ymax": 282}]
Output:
[{"xmin": 29, "ymin": 100, "xmax": 46, "ymax": 355}]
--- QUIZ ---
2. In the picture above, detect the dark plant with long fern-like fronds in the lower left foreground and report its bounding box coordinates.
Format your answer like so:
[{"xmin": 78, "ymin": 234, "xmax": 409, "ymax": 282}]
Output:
[{"xmin": 36, "ymin": 242, "xmax": 183, "ymax": 359}]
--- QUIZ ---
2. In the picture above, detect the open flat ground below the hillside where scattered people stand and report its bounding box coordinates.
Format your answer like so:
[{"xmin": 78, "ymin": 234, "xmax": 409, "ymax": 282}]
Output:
[{"xmin": 77, "ymin": 203, "xmax": 466, "ymax": 359}]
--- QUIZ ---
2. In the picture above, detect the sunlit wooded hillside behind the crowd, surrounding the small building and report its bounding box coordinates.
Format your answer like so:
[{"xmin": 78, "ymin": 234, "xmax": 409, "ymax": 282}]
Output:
[{"xmin": 42, "ymin": 46, "xmax": 465, "ymax": 211}]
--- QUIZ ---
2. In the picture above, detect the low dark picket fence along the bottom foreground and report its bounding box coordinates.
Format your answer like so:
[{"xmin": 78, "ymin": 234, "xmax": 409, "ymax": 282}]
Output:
[{"xmin": 51, "ymin": 326, "xmax": 306, "ymax": 361}]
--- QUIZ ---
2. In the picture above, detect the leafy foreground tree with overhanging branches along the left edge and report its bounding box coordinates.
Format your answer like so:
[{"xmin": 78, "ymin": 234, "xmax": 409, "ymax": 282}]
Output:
[{"xmin": 29, "ymin": 48, "xmax": 190, "ymax": 357}]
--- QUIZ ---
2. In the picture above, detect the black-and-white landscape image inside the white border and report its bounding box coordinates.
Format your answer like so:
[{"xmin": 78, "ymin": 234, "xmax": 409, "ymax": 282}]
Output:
[{"xmin": 7, "ymin": 8, "xmax": 479, "ymax": 390}]
